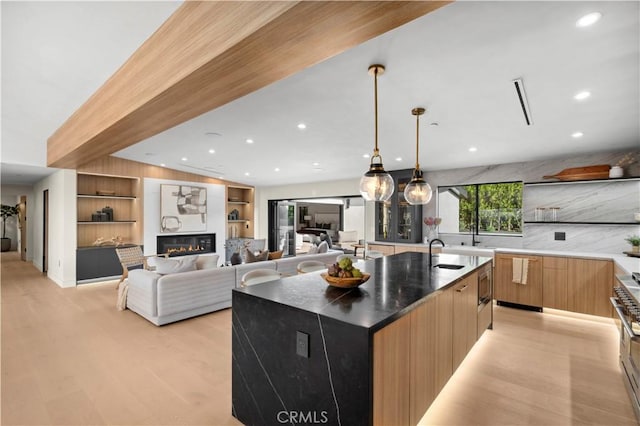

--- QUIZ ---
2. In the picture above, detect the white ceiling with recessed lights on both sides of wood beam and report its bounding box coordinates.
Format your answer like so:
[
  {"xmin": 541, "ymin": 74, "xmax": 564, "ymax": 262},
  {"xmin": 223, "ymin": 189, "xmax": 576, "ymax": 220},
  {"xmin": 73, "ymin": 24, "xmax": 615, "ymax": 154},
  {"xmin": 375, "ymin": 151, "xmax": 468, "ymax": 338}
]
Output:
[{"xmin": 2, "ymin": 1, "xmax": 640, "ymax": 186}]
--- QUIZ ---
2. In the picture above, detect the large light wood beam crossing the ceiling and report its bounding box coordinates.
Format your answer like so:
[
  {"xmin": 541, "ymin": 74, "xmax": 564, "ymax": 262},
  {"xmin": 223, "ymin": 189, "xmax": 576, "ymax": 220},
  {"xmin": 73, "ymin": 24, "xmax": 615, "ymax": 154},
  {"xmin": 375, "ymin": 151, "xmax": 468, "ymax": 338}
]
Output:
[{"xmin": 47, "ymin": 1, "xmax": 450, "ymax": 168}]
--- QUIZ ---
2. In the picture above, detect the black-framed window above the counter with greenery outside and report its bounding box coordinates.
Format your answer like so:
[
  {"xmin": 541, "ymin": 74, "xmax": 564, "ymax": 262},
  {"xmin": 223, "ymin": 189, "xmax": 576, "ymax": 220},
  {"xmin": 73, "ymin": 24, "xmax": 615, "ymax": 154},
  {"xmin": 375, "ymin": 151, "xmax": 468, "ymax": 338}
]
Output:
[{"xmin": 438, "ymin": 182, "xmax": 522, "ymax": 235}]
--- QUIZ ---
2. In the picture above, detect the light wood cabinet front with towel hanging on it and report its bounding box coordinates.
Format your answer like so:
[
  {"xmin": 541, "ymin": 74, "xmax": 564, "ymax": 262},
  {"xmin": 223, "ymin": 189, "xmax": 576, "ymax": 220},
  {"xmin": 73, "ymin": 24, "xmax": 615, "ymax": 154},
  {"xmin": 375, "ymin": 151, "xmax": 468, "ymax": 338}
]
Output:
[{"xmin": 494, "ymin": 253, "xmax": 542, "ymax": 309}]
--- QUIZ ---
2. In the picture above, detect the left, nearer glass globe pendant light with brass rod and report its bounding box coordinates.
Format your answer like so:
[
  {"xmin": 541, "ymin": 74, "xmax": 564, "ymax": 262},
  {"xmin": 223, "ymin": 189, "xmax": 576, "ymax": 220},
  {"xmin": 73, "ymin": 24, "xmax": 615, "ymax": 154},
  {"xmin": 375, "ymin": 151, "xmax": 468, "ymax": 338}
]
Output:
[{"xmin": 360, "ymin": 65, "xmax": 395, "ymax": 201}]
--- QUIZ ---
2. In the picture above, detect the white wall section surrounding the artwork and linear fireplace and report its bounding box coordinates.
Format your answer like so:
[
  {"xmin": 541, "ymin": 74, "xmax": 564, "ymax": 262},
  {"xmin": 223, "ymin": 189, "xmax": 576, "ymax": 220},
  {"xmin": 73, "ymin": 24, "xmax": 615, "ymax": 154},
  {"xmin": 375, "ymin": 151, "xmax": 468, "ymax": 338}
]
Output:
[{"xmin": 143, "ymin": 178, "xmax": 226, "ymax": 259}]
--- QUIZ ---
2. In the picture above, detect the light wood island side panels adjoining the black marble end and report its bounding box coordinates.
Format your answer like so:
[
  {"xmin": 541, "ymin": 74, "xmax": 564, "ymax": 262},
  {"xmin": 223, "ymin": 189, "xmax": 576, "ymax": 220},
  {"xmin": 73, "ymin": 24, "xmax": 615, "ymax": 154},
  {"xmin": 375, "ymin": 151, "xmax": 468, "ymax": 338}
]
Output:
[{"xmin": 373, "ymin": 289, "xmax": 456, "ymax": 425}]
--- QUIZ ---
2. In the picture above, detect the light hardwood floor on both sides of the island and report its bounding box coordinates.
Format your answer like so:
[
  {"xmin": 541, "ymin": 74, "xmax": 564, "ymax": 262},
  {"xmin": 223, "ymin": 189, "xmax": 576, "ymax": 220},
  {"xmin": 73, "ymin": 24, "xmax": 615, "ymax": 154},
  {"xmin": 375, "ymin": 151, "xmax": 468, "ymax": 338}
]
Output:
[{"xmin": 1, "ymin": 253, "xmax": 635, "ymax": 425}]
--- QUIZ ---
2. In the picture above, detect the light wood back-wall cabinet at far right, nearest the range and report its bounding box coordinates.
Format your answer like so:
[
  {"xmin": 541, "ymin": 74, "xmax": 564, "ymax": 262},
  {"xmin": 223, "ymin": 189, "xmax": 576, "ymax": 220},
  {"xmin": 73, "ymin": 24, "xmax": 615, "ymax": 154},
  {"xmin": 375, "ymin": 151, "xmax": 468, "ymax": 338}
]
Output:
[{"xmin": 567, "ymin": 258, "xmax": 613, "ymax": 317}]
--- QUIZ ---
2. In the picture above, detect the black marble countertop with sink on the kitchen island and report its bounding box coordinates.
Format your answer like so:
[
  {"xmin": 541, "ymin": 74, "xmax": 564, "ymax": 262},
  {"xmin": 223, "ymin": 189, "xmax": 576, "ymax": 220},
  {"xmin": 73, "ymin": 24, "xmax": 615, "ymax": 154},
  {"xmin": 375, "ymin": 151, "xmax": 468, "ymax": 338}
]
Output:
[{"xmin": 233, "ymin": 252, "xmax": 492, "ymax": 332}]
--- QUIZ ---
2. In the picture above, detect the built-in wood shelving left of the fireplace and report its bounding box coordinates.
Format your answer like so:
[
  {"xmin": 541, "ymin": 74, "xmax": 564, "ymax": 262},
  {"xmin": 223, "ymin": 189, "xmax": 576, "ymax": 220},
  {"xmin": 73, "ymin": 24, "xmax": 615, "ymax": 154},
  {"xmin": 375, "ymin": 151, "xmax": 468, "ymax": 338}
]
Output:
[{"xmin": 77, "ymin": 172, "xmax": 140, "ymax": 248}]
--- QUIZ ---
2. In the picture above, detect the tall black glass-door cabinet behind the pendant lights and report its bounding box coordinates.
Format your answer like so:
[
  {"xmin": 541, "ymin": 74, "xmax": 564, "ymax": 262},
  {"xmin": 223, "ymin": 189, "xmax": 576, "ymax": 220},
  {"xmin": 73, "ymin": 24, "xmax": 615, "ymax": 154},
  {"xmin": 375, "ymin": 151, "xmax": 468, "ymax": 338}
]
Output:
[{"xmin": 376, "ymin": 169, "xmax": 422, "ymax": 243}]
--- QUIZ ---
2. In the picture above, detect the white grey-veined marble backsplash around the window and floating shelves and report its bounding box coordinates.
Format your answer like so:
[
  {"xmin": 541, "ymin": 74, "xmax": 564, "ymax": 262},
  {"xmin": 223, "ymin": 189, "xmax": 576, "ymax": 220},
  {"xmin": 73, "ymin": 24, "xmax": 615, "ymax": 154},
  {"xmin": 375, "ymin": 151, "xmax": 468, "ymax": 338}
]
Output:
[{"xmin": 423, "ymin": 150, "xmax": 640, "ymax": 253}]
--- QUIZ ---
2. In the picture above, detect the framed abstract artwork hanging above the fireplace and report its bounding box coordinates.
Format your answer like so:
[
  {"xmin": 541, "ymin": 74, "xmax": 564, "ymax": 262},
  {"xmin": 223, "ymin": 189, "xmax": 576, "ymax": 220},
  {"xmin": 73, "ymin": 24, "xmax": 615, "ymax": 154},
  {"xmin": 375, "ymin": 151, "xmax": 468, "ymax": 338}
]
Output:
[{"xmin": 160, "ymin": 184, "xmax": 207, "ymax": 233}]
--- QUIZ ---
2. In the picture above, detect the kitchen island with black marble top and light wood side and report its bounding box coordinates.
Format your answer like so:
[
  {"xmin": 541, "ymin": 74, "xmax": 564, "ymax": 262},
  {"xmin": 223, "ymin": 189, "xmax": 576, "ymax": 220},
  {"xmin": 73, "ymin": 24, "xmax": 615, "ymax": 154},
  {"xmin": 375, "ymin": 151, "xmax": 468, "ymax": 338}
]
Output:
[{"xmin": 232, "ymin": 252, "xmax": 491, "ymax": 425}]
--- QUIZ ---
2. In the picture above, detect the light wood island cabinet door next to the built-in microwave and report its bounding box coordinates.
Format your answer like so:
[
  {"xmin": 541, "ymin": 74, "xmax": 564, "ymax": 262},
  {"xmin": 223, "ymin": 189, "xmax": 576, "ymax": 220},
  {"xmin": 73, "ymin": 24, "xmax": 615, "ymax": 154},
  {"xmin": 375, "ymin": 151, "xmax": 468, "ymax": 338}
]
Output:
[{"xmin": 450, "ymin": 272, "xmax": 478, "ymax": 371}]
